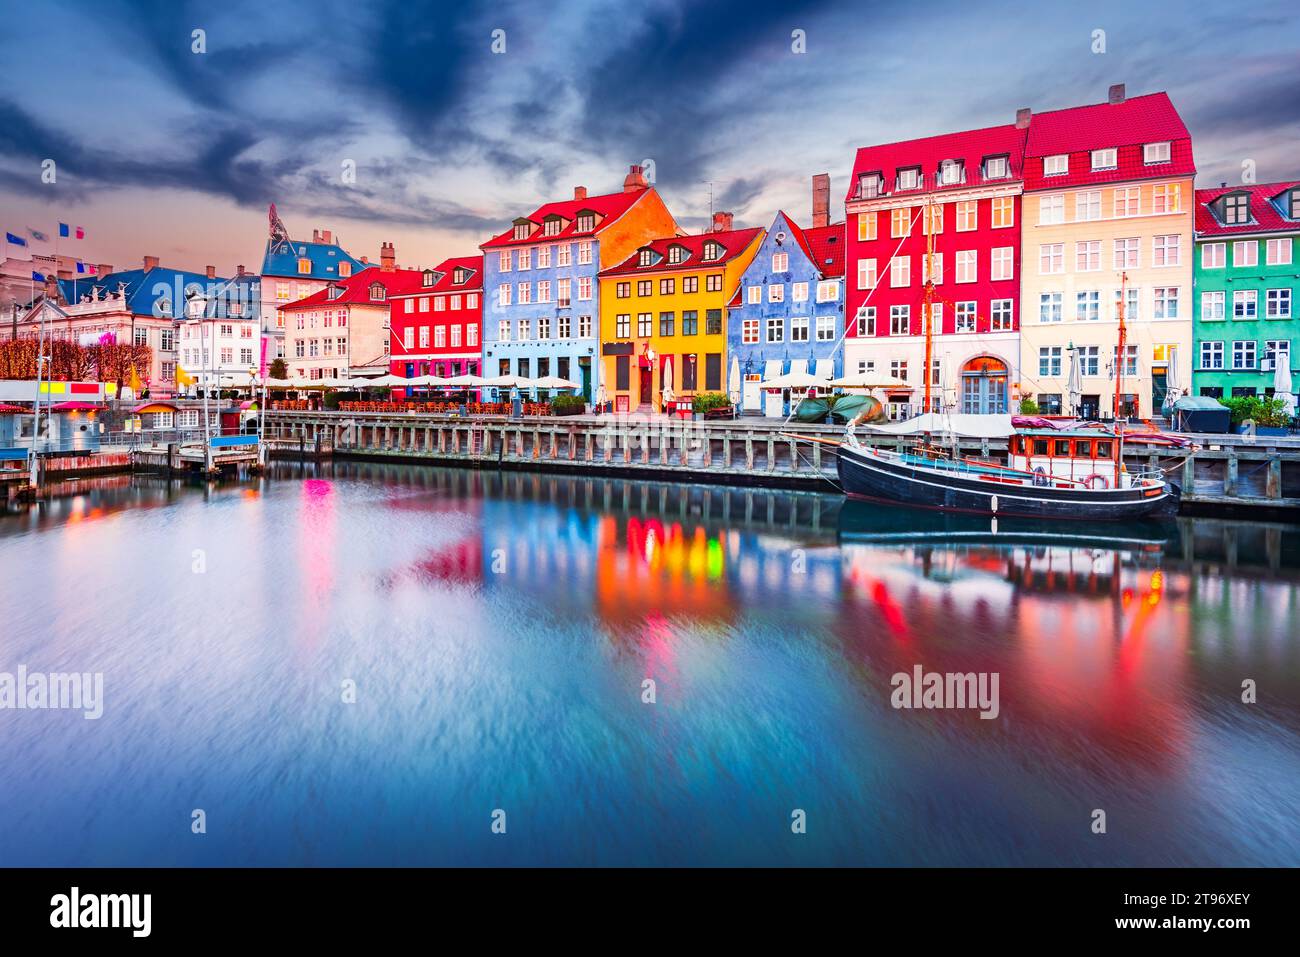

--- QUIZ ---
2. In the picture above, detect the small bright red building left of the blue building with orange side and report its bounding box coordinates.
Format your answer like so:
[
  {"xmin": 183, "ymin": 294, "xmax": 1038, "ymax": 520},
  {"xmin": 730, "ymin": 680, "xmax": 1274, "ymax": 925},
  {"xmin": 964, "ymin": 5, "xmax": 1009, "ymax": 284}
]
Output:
[{"xmin": 389, "ymin": 256, "xmax": 484, "ymax": 378}]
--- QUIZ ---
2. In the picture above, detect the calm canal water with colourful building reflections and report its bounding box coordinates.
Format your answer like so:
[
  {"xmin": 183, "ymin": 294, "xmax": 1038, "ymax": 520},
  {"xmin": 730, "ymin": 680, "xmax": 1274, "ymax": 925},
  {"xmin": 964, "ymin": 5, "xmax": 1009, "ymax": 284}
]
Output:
[{"xmin": 0, "ymin": 463, "xmax": 1300, "ymax": 866}]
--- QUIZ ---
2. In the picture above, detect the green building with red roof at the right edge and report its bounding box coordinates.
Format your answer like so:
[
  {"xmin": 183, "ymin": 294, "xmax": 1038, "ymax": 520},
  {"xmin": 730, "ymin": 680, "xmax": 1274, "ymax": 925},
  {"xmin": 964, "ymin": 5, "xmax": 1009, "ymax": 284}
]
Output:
[{"xmin": 1192, "ymin": 182, "xmax": 1300, "ymax": 398}]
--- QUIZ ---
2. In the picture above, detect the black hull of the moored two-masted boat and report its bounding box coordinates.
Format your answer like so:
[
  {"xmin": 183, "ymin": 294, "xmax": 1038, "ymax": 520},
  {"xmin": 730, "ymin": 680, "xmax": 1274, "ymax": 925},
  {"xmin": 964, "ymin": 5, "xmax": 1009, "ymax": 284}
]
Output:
[{"xmin": 837, "ymin": 446, "xmax": 1179, "ymax": 521}]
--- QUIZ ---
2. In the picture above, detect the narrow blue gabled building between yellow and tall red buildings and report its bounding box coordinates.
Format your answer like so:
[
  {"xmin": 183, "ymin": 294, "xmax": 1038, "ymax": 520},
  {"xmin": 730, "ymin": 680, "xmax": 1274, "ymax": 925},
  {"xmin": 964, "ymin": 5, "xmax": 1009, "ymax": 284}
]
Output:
[{"xmin": 727, "ymin": 204, "xmax": 845, "ymax": 416}]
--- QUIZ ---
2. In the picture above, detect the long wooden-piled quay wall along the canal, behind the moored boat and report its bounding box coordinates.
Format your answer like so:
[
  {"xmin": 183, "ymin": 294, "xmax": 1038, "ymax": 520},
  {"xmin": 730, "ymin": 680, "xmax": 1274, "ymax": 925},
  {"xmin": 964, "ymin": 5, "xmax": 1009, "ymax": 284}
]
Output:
[{"xmin": 265, "ymin": 411, "xmax": 1300, "ymax": 515}]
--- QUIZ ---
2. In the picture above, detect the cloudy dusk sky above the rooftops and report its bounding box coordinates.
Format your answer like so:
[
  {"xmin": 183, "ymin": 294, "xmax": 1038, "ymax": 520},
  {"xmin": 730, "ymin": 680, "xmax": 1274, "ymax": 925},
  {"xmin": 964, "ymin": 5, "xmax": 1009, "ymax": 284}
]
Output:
[{"xmin": 0, "ymin": 0, "xmax": 1300, "ymax": 276}]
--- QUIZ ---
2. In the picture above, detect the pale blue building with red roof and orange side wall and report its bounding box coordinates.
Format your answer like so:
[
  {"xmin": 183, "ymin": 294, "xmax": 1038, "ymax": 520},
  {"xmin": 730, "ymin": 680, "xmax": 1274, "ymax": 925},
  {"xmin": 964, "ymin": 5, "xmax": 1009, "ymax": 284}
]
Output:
[{"xmin": 480, "ymin": 166, "xmax": 680, "ymax": 402}]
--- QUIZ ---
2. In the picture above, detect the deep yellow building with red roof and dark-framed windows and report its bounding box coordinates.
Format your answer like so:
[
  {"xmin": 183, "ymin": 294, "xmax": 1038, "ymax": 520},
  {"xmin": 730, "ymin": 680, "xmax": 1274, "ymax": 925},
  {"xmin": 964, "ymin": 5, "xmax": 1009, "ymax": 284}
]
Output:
[{"xmin": 601, "ymin": 213, "xmax": 763, "ymax": 412}]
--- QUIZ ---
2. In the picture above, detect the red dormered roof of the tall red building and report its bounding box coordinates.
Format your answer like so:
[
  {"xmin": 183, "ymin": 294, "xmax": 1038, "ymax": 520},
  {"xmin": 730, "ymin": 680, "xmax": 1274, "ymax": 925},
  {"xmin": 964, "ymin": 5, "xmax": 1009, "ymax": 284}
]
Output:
[{"xmin": 845, "ymin": 124, "xmax": 1024, "ymax": 202}]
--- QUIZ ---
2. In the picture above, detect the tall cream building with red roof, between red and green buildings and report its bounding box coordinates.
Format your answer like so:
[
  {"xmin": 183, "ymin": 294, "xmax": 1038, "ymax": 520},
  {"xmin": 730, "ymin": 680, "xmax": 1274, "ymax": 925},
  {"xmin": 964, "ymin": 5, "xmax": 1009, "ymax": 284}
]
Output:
[{"xmin": 1019, "ymin": 86, "xmax": 1196, "ymax": 417}]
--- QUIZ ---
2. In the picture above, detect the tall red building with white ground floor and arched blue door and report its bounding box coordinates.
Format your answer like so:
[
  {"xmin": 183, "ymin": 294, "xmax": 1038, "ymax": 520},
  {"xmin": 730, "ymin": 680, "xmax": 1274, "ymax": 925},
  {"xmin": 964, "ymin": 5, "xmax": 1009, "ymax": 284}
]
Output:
[{"xmin": 845, "ymin": 111, "xmax": 1028, "ymax": 417}]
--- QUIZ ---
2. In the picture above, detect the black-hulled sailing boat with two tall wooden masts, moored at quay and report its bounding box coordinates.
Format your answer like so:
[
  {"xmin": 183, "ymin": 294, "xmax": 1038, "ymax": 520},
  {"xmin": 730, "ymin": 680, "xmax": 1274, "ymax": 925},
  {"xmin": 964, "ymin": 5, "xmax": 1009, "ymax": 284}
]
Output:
[{"xmin": 836, "ymin": 199, "xmax": 1182, "ymax": 521}]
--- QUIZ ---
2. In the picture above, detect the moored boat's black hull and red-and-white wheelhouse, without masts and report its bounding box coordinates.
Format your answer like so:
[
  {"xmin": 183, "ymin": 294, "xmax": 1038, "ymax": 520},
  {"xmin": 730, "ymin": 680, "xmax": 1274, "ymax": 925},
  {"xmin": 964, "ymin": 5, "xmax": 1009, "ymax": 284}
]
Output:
[{"xmin": 837, "ymin": 416, "xmax": 1182, "ymax": 521}]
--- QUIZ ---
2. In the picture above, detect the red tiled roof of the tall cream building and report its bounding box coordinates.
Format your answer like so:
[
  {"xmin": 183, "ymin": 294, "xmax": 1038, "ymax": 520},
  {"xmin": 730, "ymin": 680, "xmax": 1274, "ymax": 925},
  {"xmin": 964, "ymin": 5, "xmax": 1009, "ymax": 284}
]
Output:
[{"xmin": 1024, "ymin": 92, "xmax": 1196, "ymax": 190}]
